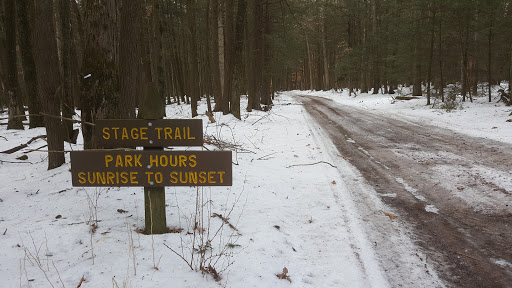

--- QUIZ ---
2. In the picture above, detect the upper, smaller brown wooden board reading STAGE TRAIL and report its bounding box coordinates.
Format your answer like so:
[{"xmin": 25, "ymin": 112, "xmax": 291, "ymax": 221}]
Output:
[{"xmin": 95, "ymin": 119, "xmax": 203, "ymax": 148}]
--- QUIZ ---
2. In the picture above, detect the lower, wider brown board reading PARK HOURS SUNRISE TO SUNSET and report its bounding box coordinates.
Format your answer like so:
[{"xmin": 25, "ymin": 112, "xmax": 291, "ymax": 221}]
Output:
[{"xmin": 71, "ymin": 150, "xmax": 233, "ymax": 187}]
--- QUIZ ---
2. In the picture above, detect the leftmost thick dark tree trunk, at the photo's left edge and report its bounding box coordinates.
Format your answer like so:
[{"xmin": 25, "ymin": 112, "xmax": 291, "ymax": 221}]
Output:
[{"xmin": 4, "ymin": 0, "xmax": 25, "ymax": 130}]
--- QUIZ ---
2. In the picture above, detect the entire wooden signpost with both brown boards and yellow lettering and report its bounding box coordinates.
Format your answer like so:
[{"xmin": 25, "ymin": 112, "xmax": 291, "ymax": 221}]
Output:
[{"xmin": 71, "ymin": 86, "xmax": 232, "ymax": 234}]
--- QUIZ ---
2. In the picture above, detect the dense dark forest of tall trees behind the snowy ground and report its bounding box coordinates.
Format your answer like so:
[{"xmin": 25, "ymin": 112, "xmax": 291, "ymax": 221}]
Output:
[{"xmin": 0, "ymin": 0, "xmax": 512, "ymax": 169}]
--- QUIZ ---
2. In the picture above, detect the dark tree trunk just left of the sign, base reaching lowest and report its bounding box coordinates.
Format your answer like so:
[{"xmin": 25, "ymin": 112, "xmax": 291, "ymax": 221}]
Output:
[{"xmin": 33, "ymin": 0, "xmax": 65, "ymax": 170}]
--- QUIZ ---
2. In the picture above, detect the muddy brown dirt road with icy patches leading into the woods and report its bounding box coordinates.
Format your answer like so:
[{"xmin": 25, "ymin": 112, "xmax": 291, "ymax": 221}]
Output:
[{"xmin": 298, "ymin": 96, "xmax": 512, "ymax": 287}]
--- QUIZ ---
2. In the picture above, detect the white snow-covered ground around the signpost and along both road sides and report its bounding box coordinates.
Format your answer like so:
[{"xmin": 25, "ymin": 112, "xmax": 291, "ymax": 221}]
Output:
[{"xmin": 0, "ymin": 91, "xmax": 512, "ymax": 287}]
